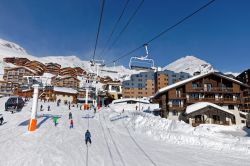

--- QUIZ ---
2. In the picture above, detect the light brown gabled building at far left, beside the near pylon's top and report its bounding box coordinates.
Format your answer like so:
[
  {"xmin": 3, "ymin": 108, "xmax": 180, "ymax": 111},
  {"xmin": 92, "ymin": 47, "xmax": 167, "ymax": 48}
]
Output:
[{"xmin": 3, "ymin": 66, "xmax": 38, "ymax": 84}]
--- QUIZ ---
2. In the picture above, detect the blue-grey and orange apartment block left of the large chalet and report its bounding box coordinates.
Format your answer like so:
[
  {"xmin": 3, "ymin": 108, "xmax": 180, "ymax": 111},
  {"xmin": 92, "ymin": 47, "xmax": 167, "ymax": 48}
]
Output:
[{"xmin": 122, "ymin": 70, "xmax": 190, "ymax": 98}]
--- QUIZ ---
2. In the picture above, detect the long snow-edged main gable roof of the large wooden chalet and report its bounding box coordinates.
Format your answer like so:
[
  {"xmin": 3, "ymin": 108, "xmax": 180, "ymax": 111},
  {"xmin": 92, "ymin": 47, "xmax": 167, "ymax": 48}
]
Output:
[{"xmin": 154, "ymin": 71, "xmax": 248, "ymax": 97}]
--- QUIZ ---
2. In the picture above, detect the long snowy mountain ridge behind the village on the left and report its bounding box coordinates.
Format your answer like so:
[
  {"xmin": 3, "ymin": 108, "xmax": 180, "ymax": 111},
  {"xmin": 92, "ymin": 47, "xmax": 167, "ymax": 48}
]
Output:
[{"xmin": 0, "ymin": 39, "xmax": 138, "ymax": 80}]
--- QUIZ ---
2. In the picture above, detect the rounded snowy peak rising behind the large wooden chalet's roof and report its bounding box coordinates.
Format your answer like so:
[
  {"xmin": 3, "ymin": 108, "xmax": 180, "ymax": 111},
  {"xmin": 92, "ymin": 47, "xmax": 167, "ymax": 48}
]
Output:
[{"xmin": 163, "ymin": 56, "xmax": 214, "ymax": 75}]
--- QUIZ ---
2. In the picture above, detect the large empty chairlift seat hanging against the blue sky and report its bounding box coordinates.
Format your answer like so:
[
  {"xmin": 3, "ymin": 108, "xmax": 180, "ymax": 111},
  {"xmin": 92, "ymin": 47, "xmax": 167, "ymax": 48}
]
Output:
[{"xmin": 129, "ymin": 44, "xmax": 155, "ymax": 70}]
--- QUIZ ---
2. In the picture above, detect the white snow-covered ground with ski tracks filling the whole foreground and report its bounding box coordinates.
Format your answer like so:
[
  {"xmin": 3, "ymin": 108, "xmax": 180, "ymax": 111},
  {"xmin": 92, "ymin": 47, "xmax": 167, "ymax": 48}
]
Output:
[{"xmin": 0, "ymin": 97, "xmax": 250, "ymax": 166}]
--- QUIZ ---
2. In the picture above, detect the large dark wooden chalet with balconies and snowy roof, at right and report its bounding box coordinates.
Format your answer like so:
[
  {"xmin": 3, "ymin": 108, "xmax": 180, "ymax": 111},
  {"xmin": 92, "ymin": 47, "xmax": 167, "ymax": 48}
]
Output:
[{"xmin": 154, "ymin": 72, "xmax": 249, "ymax": 126}]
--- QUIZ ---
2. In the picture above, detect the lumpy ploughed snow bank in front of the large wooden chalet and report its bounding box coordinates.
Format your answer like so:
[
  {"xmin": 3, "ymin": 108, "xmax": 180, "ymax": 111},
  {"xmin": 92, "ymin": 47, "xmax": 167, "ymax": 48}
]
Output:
[{"xmin": 120, "ymin": 113, "xmax": 250, "ymax": 153}]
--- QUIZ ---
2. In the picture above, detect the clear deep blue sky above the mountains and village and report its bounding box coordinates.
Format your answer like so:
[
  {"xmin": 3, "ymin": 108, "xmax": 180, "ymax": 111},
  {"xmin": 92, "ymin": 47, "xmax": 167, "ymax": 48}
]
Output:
[{"xmin": 0, "ymin": 0, "xmax": 250, "ymax": 72}]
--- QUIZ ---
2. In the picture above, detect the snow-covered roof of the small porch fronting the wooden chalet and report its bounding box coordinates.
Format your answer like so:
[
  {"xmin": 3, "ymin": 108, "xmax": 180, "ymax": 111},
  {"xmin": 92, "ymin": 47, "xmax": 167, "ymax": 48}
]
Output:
[{"xmin": 186, "ymin": 102, "xmax": 234, "ymax": 115}]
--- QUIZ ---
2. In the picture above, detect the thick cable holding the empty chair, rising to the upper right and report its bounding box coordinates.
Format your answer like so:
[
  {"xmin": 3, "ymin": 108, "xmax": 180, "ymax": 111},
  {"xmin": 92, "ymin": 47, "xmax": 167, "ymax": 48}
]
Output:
[{"xmin": 107, "ymin": 0, "xmax": 215, "ymax": 64}]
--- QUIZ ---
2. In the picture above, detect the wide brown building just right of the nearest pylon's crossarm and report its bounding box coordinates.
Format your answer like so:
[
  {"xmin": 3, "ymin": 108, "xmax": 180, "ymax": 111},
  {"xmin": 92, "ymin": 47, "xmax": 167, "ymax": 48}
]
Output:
[{"xmin": 51, "ymin": 76, "xmax": 80, "ymax": 89}]
